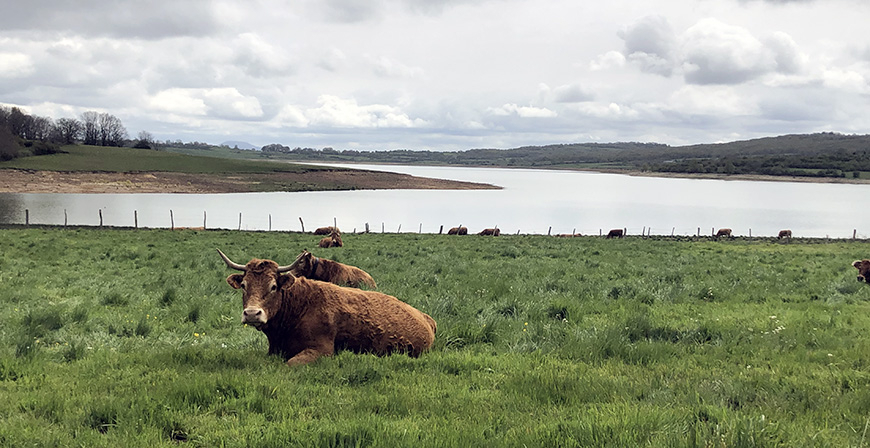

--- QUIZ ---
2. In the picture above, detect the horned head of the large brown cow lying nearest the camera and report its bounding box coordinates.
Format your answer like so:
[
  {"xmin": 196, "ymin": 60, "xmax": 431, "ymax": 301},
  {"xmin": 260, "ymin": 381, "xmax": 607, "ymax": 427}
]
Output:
[{"xmin": 218, "ymin": 250, "xmax": 294, "ymax": 328}]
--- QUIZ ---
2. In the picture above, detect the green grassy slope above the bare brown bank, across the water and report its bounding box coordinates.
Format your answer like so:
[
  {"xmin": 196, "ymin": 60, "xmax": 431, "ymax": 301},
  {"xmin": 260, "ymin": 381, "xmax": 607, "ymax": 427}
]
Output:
[{"xmin": 0, "ymin": 145, "xmax": 334, "ymax": 174}]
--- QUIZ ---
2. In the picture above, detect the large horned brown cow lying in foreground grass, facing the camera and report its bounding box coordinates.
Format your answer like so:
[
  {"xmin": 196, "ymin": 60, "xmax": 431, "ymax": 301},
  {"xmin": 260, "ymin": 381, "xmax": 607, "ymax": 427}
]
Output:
[{"xmin": 218, "ymin": 249, "xmax": 436, "ymax": 367}]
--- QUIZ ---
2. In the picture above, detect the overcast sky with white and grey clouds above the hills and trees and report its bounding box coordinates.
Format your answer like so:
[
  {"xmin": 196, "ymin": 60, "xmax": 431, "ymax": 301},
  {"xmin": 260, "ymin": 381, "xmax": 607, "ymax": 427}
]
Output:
[{"xmin": 0, "ymin": 0, "xmax": 870, "ymax": 150}]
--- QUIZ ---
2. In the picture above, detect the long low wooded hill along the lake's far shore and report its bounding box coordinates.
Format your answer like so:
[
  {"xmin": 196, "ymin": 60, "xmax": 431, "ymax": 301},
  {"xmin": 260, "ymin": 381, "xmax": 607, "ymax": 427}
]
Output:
[{"xmin": 242, "ymin": 132, "xmax": 870, "ymax": 178}]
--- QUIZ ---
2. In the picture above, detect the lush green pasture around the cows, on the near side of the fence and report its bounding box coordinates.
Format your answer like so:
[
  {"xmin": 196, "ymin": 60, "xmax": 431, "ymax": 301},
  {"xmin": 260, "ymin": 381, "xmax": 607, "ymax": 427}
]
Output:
[{"xmin": 0, "ymin": 227, "xmax": 870, "ymax": 448}]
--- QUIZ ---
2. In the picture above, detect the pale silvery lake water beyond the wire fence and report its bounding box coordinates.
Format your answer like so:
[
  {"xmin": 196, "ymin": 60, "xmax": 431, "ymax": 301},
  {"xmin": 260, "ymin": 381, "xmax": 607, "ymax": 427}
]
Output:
[{"xmin": 0, "ymin": 165, "xmax": 870, "ymax": 238}]
